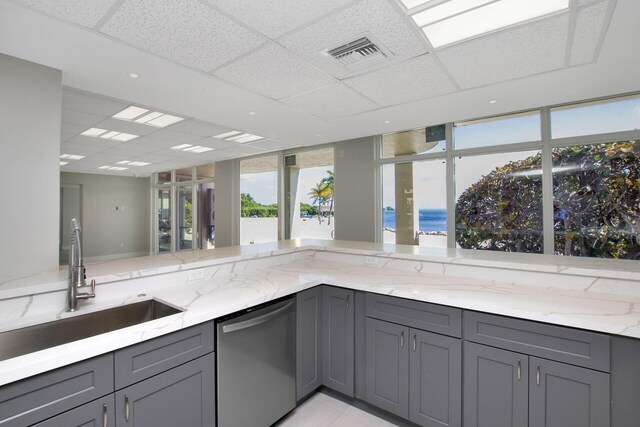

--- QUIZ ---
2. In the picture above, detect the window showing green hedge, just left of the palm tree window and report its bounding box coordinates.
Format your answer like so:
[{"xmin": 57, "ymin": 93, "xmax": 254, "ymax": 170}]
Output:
[{"xmin": 240, "ymin": 156, "xmax": 278, "ymax": 245}]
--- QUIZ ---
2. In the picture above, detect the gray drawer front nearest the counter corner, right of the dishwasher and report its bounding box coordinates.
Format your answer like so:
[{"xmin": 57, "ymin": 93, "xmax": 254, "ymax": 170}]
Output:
[{"xmin": 366, "ymin": 293, "xmax": 462, "ymax": 338}]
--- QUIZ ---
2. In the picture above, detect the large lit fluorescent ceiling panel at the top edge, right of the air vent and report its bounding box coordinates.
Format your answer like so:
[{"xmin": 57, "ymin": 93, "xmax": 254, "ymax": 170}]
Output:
[{"xmin": 412, "ymin": 0, "xmax": 569, "ymax": 48}]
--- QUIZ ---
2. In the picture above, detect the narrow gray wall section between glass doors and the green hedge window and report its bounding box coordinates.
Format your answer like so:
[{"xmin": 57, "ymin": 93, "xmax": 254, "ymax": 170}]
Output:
[{"xmin": 215, "ymin": 160, "xmax": 240, "ymax": 248}]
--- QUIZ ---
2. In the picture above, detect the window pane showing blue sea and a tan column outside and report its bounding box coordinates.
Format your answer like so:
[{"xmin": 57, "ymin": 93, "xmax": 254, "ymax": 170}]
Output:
[{"xmin": 382, "ymin": 159, "xmax": 447, "ymax": 248}]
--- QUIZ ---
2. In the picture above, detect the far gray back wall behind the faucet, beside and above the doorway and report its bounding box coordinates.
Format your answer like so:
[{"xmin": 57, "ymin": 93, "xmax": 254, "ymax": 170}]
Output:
[{"xmin": 61, "ymin": 172, "xmax": 151, "ymax": 261}]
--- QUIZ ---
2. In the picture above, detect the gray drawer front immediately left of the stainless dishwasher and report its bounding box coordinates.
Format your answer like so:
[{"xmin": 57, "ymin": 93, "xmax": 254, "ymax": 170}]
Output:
[{"xmin": 115, "ymin": 322, "xmax": 213, "ymax": 390}]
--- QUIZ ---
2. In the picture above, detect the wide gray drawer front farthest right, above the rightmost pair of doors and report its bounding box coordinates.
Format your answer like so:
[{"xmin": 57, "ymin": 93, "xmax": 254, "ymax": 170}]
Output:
[{"xmin": 464, "ymin": 311, "xmax": 611, "ymax": 372}]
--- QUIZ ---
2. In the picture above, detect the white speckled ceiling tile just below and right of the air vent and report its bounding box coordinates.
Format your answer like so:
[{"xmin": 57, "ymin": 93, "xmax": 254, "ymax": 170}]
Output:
[{"xmin": 344, "ymin": 55, "xmax": 456, "ymax": 105}]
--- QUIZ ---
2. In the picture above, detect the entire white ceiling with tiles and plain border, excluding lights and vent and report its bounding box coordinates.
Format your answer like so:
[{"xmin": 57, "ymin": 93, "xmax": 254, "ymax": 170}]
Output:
[{"xmin": 0, "ymin": 0, "xmax": 640, "ymax": 176}]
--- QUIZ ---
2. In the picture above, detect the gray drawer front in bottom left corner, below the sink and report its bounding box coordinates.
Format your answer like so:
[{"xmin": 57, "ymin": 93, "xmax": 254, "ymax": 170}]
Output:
[{"xmin": 0, "ymin": 353, "xmax": 113, "ymax": 427}]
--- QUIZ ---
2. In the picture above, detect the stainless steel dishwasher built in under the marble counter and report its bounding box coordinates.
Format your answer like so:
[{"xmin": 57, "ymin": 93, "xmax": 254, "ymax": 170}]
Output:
[{"xmin": 216, "ymin": 297, "xmax": 296, "ymax": 427}]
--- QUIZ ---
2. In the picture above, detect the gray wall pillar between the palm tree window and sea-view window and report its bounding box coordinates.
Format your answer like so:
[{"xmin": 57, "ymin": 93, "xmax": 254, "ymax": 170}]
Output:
[{"xmin": 334, "ymin": 136, "xmax": 378, "ymax": 242}]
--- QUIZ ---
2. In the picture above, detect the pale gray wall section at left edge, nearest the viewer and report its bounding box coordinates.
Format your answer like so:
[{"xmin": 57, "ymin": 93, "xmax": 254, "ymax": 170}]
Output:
[{"xmin": 0, "ymin": 54, "xmax": 62, "ymax": 283}]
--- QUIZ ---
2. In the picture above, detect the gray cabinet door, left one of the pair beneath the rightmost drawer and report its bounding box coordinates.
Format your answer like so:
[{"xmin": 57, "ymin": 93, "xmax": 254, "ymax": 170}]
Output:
[{"xmin": 463, "ymin": 342, "xmax": 528, "ymax": 427}]
